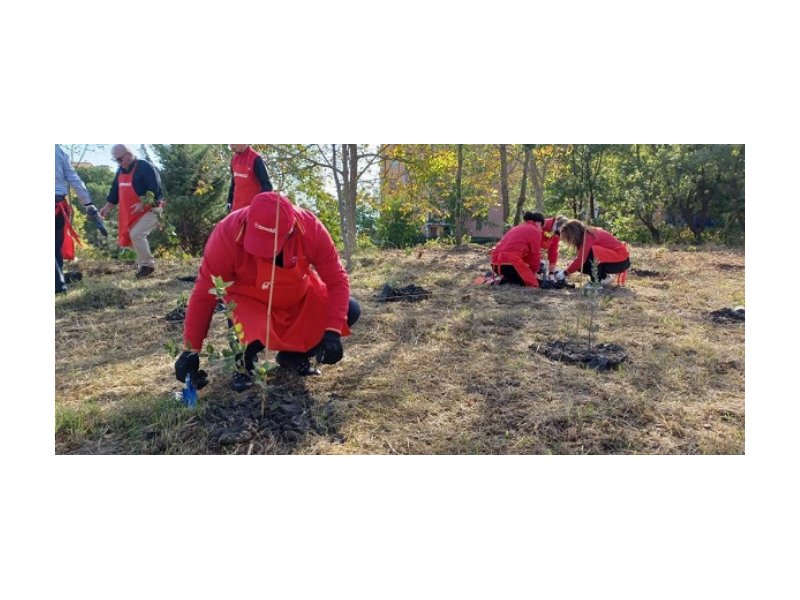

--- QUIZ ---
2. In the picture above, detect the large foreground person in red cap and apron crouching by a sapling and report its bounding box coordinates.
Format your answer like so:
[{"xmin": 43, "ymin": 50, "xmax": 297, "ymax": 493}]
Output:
[{"xmin": 175, "ymin": 192, "xmax": 361, "ymax": 391}]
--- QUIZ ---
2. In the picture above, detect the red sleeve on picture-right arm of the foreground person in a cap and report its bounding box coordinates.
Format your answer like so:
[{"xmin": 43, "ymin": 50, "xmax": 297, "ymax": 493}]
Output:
[{"xmin": 303, "ymin": 213, "xmax": 350, "ymax": 333}]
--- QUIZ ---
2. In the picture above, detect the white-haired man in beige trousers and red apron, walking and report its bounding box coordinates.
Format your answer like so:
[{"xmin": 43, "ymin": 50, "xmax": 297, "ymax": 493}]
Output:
[{"xmin": 100, "ymin": 144, "xmax": 164, "ymax": 279}]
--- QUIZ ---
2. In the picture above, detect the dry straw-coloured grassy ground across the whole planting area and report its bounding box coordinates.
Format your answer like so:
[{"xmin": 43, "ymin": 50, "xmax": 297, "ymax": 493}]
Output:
[{"xmin": 55, "ymin": 246, "xmax": 745, "ymax": 454}]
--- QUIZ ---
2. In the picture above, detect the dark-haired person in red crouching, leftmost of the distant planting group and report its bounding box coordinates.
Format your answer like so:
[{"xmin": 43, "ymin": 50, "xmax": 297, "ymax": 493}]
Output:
[{"xmin": 491, "ymin": 212, "xmax": 542, "ymax": 287}]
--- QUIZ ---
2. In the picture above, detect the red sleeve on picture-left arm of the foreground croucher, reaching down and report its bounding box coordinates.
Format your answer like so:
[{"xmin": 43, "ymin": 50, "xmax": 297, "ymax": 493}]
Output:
[{"xmin": 183, "ymin": 221, "xmax": 236, "ymax": 350}]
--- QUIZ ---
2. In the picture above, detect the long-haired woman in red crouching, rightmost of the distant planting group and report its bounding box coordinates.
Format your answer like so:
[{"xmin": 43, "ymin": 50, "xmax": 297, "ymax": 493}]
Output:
[{"xmin": 555, "ymin": 219, "xmax": 631, "ymax": 283}]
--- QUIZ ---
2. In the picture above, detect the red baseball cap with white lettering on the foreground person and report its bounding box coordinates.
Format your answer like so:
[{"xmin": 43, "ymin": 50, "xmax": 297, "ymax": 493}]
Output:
[{"xmin": 244, "ymin": 192, "xmax": 297, "ymax": 258}]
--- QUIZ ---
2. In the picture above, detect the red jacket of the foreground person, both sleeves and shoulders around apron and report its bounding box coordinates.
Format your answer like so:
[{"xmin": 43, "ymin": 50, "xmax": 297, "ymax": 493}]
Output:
[{"xmin": 188, "ymin": 206, "xmax": 350, "ymax": 349}]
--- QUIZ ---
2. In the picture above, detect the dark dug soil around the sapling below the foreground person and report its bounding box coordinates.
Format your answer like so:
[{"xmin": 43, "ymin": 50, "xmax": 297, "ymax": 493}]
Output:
[{"xmin": 200, "ymin": 376, "xmax": 344, "ymax": 454}]
